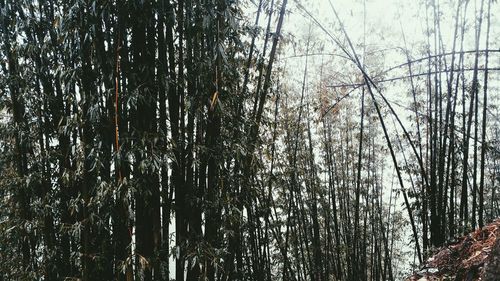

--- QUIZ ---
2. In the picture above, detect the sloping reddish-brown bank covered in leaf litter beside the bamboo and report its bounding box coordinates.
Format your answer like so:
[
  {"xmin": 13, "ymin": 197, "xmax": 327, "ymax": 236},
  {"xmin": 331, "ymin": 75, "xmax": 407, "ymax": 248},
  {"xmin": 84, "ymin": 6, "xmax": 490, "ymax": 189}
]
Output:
[{"xmin": 407, "ymin": 219, "xmax": 500, "ymax": 281}]
